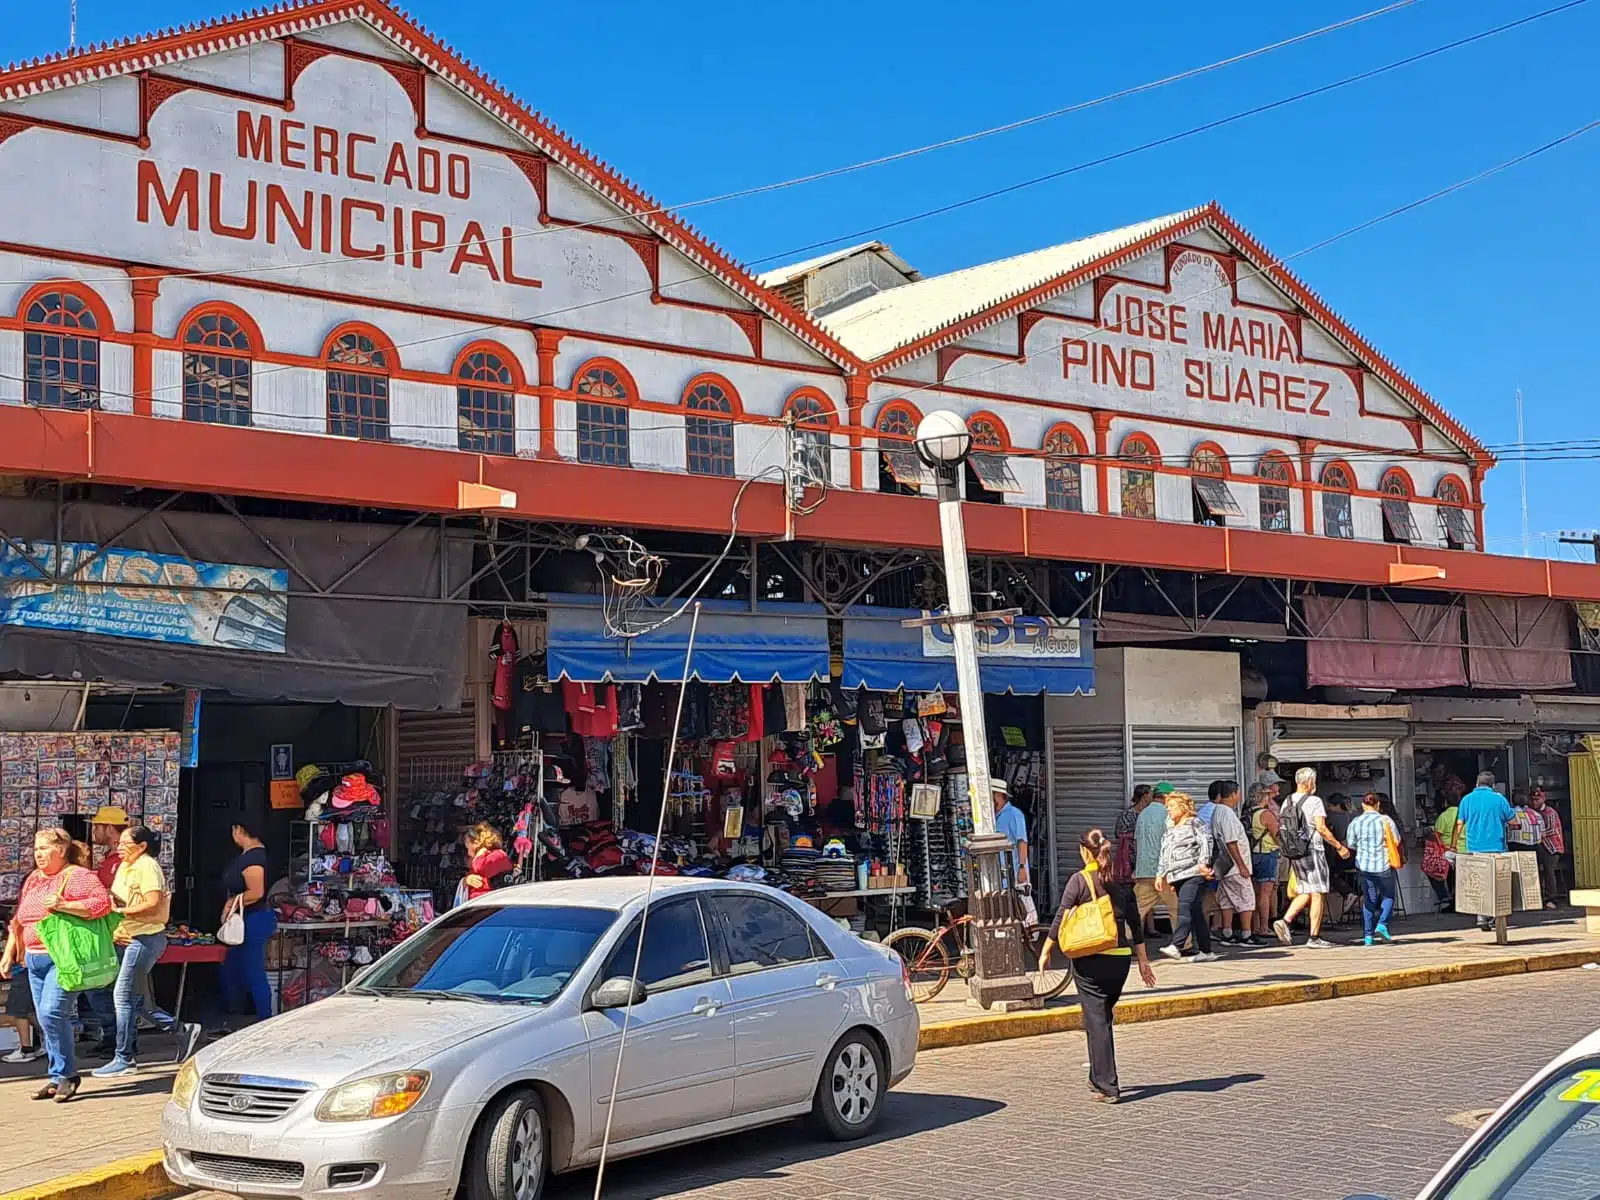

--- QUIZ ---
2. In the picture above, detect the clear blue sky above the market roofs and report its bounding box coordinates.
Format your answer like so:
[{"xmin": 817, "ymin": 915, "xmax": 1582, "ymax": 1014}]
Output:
[{"xmin": 0, "ymin": 0, "xmax": 1600, "ymax": 552}]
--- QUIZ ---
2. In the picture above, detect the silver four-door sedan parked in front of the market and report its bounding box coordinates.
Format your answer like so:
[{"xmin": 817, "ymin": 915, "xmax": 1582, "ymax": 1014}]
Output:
[{"xmin": 162, "ymin": 878, "xmax": 918, "ymax": 1200}]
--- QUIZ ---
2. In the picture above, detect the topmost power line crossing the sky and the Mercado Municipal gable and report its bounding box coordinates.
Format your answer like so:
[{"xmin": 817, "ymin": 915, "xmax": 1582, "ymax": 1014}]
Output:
[{"xmin": 0, "ymin": 0, "xmax": 1421, "ymax": 286}]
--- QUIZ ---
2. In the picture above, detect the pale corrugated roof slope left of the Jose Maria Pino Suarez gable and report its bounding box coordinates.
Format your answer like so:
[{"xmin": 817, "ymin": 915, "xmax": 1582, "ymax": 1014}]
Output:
[{"xmin": 812, "ymin": 208, "xmax": 1202, "ymax": 360}]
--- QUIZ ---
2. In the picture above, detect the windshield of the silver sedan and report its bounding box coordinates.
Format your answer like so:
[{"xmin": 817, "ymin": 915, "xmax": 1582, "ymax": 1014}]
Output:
[{"xmin": 349, "ymin": 904, "xmax": 616, "ymax": 1003}]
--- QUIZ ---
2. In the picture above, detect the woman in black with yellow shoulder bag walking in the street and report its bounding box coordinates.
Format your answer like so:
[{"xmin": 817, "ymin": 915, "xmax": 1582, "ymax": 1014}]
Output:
[{"xmin": 1040, "ymin": 829, "xmax": 1155, "ymax": 1104}]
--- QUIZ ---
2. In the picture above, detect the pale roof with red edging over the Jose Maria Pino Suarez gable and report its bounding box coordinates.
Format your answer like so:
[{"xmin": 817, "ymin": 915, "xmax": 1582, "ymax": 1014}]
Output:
[{"xmin": 818, "ymin": 202, "xmax": 1494, "ymax": 464}]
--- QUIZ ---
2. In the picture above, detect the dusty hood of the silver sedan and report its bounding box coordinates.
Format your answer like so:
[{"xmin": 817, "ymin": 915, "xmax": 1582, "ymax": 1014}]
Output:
[{"xmin": 197, "ymin": 995, "xmax": 531, "ymax": 1088}]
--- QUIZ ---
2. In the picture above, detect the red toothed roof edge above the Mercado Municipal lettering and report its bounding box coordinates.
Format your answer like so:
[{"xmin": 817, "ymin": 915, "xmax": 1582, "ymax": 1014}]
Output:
[{"xmin": 0, "ymin": 0, "xmax": 859, "ymax": 368}]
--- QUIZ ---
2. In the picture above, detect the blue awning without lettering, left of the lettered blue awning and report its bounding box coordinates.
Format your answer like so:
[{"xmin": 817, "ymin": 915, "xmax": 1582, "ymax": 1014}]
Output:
[{"xmin": 549, "ymin": 592, "xmax": 829, "ymax": 683}]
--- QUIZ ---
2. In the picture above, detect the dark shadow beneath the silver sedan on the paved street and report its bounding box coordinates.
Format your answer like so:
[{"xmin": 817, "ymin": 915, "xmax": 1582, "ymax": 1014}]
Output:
[{"xmin": 549, "ymin": 1091, "xmax": 1005, "ymax": 1200}]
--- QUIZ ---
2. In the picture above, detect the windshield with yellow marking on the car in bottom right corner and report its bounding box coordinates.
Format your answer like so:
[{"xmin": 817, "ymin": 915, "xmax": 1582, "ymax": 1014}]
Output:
[{"xmin": 1440, "ymin": 1058, "xmax": 1600, "ymax": 1200}]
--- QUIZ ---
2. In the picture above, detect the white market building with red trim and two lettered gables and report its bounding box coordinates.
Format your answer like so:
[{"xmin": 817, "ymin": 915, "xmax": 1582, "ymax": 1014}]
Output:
[{"xmin": 0, "ymin": 0, "xmax": 1600, "ymax": 994}]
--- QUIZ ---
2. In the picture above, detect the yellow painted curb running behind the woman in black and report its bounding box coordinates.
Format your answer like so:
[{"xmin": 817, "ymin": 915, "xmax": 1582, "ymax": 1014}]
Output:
[{"xmin": 915, "ymin": 947, "xmax": 1600, "ymax": 1049}]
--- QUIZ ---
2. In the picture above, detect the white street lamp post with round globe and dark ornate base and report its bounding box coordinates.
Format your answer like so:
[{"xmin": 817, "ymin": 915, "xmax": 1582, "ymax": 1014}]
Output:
[{"xmin": 917, "ymin": 411, "xmax": 1034, "ymax": 1008}]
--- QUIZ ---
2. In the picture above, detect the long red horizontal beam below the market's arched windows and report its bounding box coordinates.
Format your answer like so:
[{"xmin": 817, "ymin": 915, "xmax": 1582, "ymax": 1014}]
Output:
[{"xmin": 0, "ymin": 405, "xmax": 1600, "ymax": 602}]
